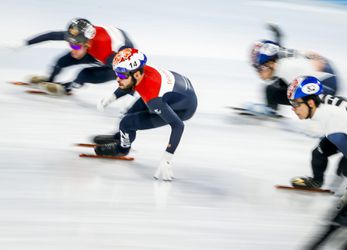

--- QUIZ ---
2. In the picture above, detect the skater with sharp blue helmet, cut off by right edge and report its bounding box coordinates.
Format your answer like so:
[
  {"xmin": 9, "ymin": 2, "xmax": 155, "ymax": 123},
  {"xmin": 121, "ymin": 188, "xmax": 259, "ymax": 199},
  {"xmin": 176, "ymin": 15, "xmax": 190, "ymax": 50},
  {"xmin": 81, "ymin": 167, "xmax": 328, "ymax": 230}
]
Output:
[{"xmin": 287, "ymin": 76, "xmax": 347, "ymax": 192}]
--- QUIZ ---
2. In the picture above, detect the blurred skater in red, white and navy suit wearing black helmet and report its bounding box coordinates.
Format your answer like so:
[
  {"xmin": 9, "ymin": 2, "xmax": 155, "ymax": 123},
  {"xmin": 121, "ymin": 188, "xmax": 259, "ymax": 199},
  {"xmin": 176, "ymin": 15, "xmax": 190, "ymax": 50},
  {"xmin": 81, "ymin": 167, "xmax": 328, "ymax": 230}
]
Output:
[{"xmin": 26, "ymin": 18, "xmax": 134, "ymax": 93}]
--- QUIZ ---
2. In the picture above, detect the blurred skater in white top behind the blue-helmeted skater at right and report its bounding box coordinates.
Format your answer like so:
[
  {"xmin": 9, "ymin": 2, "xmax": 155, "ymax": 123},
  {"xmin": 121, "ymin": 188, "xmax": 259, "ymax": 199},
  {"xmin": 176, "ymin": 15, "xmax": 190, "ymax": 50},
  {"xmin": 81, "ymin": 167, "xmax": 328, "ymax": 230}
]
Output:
[{"xmin": 249, "ymin": 40, "xmax": 339, "ymax": 116}]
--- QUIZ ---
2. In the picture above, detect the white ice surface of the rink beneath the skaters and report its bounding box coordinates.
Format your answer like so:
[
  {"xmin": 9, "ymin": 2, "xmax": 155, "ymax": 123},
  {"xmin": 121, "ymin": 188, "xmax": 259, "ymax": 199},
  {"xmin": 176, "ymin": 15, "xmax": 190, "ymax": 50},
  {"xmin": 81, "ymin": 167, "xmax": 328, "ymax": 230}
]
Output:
[{"xmin": 0, "ymin": 0, "xmax": 347, "ymax": 250}]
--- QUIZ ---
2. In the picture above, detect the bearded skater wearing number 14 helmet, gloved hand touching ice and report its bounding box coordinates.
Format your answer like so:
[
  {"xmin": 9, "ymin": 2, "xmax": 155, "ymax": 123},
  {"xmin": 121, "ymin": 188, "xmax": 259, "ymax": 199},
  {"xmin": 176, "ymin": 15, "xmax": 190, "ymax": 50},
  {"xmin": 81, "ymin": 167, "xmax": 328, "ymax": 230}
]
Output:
[{"xmin": 95, "ymin": 48, "xmax": 197, "ymax": 180}]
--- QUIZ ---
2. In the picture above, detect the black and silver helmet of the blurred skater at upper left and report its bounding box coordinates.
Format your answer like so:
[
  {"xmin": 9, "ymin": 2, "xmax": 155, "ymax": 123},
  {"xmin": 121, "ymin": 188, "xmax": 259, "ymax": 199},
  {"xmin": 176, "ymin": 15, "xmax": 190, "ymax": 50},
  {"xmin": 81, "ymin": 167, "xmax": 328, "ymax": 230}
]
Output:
[{"xmin": 65, "ymin": 18, "xmax": 95, "ymax": 43}]
